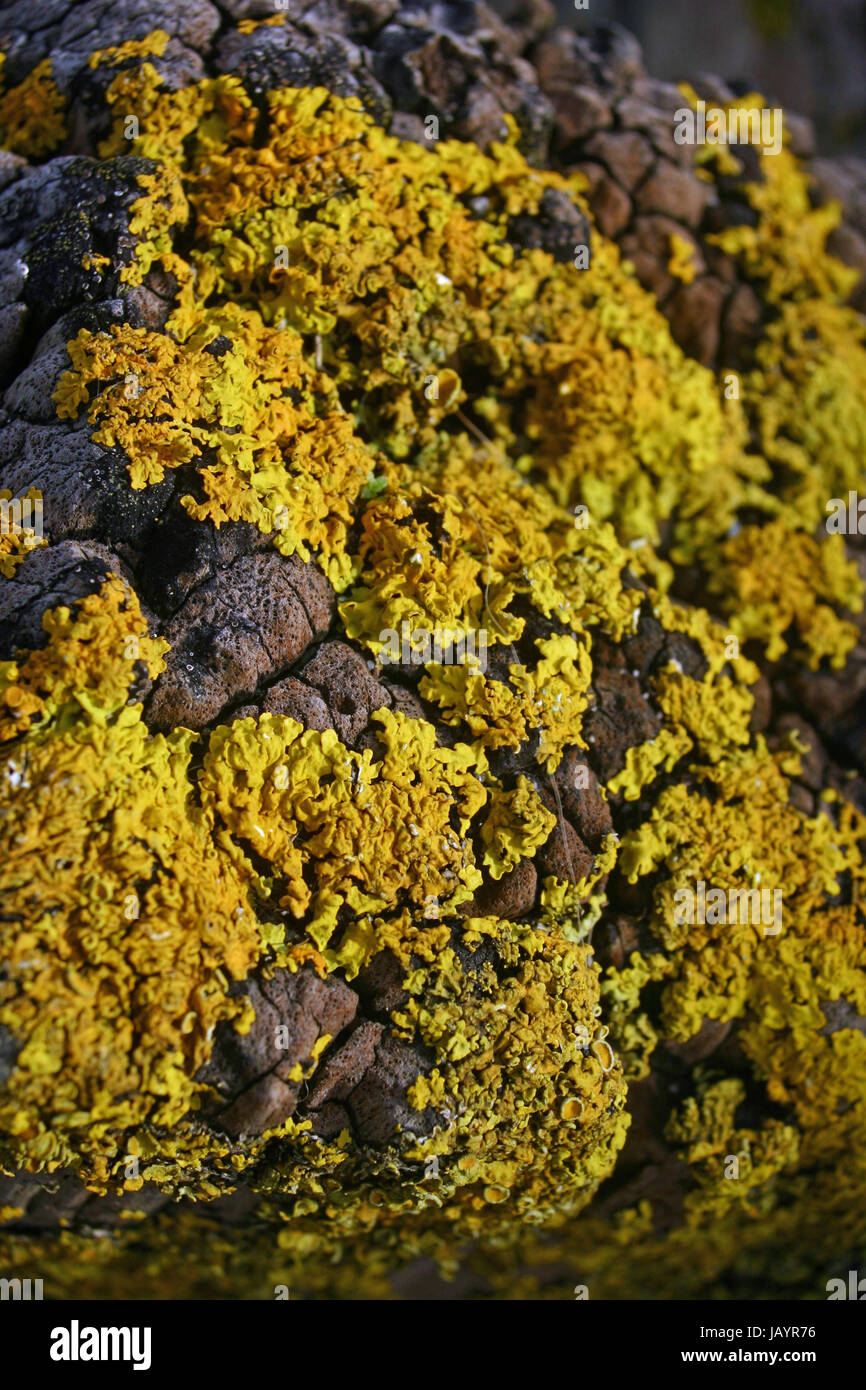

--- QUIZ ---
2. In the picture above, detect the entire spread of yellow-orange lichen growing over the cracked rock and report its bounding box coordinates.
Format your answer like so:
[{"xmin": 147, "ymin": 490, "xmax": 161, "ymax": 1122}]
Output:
[{"xmin": 0, "ymin": 27, "xmax": 866, "ymax": 1297}]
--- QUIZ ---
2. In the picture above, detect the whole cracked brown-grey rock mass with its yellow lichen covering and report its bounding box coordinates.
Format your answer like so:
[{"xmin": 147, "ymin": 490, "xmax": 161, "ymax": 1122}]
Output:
[{"xmin": 0, "ymin": 0, "xmax": 866, "ymax": 1298}]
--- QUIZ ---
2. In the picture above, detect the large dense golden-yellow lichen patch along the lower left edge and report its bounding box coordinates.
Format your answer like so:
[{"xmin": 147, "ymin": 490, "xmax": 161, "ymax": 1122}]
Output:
[{"xmin": 0, "ymin": 581, "xmax": 261, "ymax": 1179}]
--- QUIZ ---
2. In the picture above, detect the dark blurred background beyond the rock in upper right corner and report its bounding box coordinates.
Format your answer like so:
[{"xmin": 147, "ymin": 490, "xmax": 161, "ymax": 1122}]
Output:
[{"xmin": 488, "ymin": 0, "xmax": 866, "ymax": 154}]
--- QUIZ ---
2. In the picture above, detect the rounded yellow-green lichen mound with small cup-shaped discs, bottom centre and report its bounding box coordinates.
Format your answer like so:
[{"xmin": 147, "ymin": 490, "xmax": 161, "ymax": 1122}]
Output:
[{"xmin": 208, "ymin": 917, "xmax": 628, "ymax": 1289}]
